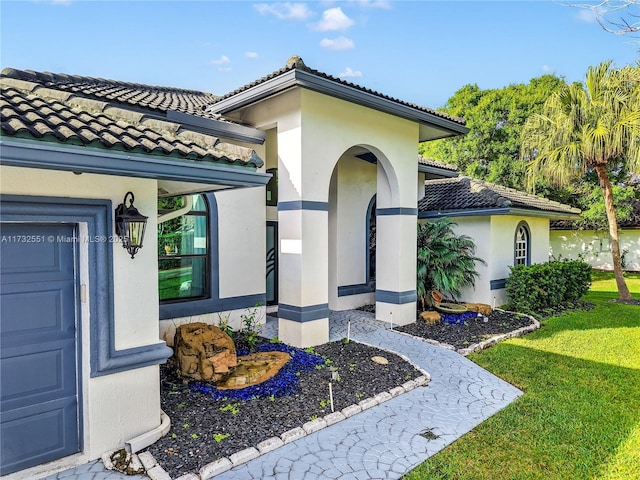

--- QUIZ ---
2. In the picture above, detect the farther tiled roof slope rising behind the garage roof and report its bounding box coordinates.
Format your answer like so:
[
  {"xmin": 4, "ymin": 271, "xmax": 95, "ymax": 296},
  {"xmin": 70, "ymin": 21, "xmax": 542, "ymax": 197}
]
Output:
[{"xmin": 2, "ymin": 68, "xmax": 217, "ymax": 118}]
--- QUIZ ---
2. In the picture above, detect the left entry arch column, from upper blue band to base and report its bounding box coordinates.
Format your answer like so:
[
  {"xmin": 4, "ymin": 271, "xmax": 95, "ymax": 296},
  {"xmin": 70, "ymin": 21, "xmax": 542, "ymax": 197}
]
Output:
[{"xmin": 278, "ymin": 204, "xmax": 329, "ymax": 347}]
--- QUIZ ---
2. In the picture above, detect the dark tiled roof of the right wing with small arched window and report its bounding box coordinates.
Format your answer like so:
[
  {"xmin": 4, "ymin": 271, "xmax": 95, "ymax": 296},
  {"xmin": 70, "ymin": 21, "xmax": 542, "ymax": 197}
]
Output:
[{"xmin": 418, "ymin": 176, "xmax": 580, "ymax": 215}]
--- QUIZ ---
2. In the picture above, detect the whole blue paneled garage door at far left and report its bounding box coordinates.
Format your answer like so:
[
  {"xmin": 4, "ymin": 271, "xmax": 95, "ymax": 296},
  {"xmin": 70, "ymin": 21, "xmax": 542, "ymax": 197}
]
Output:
[{"xmin": 0, "ymin": 223, "xmax": 80, "ymax": 475}]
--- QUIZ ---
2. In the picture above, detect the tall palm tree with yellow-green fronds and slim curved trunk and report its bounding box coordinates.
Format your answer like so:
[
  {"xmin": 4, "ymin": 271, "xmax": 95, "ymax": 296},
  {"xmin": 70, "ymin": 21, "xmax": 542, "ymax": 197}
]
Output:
[{"xmin": 521, "ymin": 61, "xmax": 640, "ymax": 300}]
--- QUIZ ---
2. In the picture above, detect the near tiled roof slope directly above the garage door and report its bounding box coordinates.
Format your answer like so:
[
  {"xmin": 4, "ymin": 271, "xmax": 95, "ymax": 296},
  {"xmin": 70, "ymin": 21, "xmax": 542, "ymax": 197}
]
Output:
[{"xmin": 0, "ymin": 77, "xmax": 263, "ymax": 168}]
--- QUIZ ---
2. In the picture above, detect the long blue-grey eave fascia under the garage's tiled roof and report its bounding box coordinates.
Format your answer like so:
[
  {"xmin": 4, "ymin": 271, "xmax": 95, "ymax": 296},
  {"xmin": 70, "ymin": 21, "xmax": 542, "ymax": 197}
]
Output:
[{"xmin": 0, "ymin": 139, "xmax": 271, "ymax": 187}]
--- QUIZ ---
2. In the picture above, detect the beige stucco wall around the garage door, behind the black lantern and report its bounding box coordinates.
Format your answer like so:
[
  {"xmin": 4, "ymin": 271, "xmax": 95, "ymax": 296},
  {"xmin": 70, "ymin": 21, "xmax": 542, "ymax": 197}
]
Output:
[{"xmin": 0, "ymin": 166, "xmax": 165, "ymax": 474}]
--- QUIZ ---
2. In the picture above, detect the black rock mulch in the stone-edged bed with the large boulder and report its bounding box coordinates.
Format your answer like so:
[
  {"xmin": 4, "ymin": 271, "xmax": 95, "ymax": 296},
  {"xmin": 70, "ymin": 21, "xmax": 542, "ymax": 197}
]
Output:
[{"xmin": 148, "ymin": 340, "xmax": 421, "ymax": 478}]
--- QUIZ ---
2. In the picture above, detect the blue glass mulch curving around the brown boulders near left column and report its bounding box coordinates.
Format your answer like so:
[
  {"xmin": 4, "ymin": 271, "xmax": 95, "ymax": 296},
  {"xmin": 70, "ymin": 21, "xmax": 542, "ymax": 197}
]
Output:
[{"xmin": 189, "ymin": 343, "xmax": 325, "ymax": 401}]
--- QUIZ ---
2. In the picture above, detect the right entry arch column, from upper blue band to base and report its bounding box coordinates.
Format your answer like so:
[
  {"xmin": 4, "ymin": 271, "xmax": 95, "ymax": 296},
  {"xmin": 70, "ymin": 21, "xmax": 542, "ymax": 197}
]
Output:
[{"xmin": 376, "ymin": 212, "xmax": 417, "ymax": 325}]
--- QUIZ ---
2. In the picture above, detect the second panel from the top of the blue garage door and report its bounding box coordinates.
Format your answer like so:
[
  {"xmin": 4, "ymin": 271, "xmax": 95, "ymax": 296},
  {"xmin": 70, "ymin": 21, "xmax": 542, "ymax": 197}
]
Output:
[{"xmin": 0, "ymin": 280, "xmax": 76, "ymax": 343}]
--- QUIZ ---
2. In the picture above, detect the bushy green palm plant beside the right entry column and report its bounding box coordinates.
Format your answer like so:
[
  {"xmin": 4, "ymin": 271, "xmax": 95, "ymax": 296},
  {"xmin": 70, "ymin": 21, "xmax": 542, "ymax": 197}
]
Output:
[{"xmin": 416, "ymin": 217, "xmax": 486, "ymax": 309}]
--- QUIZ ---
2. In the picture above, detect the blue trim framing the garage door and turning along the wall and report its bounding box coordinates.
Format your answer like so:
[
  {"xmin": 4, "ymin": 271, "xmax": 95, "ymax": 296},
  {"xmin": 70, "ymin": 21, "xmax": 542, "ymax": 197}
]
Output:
[{"xmin": 0, "ymin": 195, "xmax": 173, "ymax": 377}]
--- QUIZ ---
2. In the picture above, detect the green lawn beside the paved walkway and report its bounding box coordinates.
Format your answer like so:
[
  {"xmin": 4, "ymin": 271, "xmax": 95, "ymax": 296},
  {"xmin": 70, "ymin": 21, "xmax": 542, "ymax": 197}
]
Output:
[{"xmin": 405, "ymin": 272, "xmax": 640, "ymax": 480}]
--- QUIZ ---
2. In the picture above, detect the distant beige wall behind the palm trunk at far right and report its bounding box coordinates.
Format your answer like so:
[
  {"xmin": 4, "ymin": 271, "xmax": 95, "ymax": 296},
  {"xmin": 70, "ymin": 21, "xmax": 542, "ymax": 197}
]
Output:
[{"xmin": 549, "ymin": 229, "xmax": 640, "ymax": 271}]
